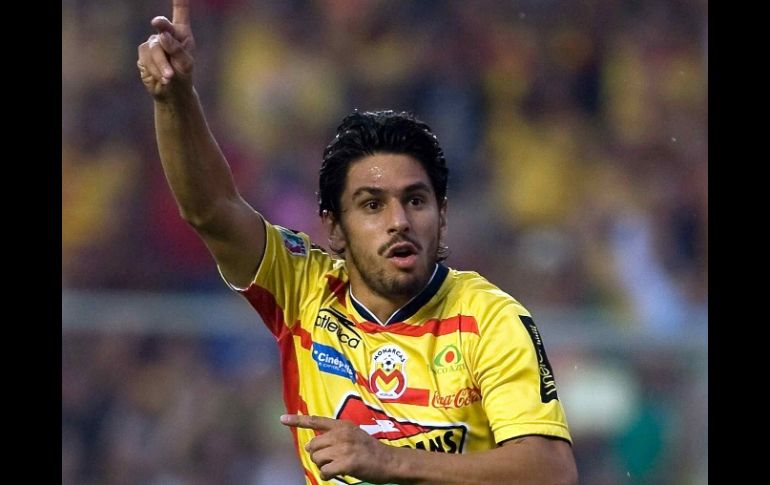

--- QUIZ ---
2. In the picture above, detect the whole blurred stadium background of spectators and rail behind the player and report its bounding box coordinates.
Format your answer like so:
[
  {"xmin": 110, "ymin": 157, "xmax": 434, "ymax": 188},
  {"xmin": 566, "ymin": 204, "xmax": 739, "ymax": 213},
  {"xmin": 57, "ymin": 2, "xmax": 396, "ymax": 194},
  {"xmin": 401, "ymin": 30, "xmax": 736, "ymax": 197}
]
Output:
[{"xmin": 62, "ymin": 0, "xmax": 708, "ymax": 485}]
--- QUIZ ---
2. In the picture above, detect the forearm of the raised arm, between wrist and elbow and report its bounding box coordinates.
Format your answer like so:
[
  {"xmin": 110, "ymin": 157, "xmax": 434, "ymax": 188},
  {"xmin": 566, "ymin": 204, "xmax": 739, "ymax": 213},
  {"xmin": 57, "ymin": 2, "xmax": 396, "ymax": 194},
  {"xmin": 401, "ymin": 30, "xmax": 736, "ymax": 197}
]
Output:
[{"xmin": 155, "ymin": 87, "xmax": 238, "ymax": 226}]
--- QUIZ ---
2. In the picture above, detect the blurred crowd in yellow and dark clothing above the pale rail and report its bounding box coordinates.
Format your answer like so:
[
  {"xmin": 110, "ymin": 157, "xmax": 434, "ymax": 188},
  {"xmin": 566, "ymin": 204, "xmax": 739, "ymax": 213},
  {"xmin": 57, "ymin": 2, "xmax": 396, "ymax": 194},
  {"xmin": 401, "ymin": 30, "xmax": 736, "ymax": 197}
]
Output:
[{"xmin": 62, "ymin": 0, "xmax": 708, "ymax": 332}]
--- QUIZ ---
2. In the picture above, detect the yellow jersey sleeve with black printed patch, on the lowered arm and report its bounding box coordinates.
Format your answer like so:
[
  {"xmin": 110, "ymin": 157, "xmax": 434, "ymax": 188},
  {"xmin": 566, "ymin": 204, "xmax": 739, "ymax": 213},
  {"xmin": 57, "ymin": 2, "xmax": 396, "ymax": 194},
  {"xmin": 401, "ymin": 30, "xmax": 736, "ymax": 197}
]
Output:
[{"xmin": 472, "ymin": 302, "xmax": 572, "ymax": 443}]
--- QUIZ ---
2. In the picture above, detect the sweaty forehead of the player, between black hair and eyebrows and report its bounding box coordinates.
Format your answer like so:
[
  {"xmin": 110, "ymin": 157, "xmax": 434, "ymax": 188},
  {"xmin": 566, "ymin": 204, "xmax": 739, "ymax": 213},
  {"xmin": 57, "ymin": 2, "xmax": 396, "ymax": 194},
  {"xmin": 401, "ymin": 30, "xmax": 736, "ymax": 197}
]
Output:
[{"xmin": 343, "ymin": 153, "xmax": 433, "ymax": 197}]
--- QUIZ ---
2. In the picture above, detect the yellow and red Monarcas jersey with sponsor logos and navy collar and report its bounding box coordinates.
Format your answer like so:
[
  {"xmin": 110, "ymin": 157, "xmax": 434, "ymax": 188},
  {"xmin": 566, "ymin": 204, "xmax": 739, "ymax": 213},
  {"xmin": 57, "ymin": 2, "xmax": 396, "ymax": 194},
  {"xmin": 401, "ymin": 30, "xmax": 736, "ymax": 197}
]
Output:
[{"xmin": 233, "ymin": 221, "xmax": 571, "ymax": 484}]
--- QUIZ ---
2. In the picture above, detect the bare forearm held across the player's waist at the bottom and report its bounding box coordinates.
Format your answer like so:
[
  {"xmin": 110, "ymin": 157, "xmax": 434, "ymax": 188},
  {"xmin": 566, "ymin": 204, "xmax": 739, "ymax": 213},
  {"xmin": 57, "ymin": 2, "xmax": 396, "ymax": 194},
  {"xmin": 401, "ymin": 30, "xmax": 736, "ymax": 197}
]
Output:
[{"xmin": 388, "ymin": 441, "xmax": 577, "ymax": 485}]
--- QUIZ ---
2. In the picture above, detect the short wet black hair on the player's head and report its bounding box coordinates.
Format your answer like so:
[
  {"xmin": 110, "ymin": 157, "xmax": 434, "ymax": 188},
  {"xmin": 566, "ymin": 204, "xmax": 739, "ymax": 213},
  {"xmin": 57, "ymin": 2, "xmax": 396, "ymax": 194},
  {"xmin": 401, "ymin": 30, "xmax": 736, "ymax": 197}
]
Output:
[{"xmin": 318, "ymin": 110, "xmax": 449, "ymax": 219}]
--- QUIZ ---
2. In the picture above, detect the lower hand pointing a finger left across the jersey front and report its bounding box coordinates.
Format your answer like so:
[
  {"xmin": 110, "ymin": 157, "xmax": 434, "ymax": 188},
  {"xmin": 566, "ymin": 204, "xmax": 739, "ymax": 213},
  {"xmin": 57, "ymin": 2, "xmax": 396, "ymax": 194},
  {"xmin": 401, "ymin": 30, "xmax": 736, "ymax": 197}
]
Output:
[{"xmin": 281, "ymin": 414, "xmax": 396, "ymax": 483}]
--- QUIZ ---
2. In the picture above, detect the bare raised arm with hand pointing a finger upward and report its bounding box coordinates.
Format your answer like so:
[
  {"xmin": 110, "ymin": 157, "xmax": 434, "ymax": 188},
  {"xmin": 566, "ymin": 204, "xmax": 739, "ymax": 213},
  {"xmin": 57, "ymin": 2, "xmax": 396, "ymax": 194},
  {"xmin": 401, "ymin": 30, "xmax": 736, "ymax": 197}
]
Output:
[{"xmin": 137, "ymin": 0, "xmax": 265, "ymax": 287}]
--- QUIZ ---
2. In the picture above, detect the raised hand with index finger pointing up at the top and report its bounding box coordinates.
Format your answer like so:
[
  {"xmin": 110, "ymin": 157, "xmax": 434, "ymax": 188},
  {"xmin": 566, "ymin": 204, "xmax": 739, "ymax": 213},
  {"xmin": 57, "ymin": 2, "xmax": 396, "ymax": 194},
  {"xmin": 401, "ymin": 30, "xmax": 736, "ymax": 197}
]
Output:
[{"xmin": 136, "ymin": 0, "xmax": 195, "ymax": 100}]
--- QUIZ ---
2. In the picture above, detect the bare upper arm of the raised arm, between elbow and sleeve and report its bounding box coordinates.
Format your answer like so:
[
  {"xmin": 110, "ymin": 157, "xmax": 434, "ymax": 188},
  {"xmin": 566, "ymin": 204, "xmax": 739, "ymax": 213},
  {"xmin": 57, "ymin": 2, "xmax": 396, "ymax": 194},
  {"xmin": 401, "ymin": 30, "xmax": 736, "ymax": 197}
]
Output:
[{"xmin": 196, "ymin": 199, "xmax": 266, "ymax": 288}]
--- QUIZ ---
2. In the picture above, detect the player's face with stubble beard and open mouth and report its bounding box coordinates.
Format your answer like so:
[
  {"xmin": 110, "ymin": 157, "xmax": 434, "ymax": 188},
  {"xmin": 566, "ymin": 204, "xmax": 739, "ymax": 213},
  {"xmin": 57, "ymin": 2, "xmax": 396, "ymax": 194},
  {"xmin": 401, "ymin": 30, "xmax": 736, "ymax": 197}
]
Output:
[{"xmin": 327, "ymin": 154, "xmax": 446, "ymax": 300}]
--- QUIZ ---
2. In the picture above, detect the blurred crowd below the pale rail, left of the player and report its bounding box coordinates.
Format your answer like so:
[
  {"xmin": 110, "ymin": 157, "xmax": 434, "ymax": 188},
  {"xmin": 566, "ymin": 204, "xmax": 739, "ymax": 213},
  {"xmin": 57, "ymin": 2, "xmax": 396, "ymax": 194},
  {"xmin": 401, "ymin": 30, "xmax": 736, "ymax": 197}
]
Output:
[{"xmin": 62, "ymin": 332, "xmax": 304, "ymax": 485}]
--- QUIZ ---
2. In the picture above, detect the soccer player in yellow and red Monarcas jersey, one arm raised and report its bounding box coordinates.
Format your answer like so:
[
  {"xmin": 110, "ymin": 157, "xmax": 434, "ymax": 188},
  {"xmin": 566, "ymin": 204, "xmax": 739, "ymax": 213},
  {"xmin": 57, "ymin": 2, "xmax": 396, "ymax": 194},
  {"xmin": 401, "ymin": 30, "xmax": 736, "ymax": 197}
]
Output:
[{"xmin": 137, "ymin": 0, "xmax": 577, "ymax": 485}]
